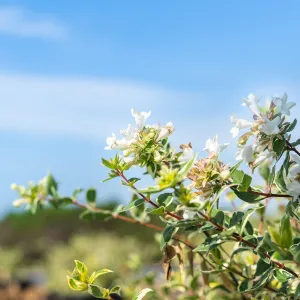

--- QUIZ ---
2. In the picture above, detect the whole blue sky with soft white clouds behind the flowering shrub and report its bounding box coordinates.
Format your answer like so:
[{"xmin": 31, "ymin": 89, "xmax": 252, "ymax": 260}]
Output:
[{"xmin": 0, "ymin": 0, "xmax": 300, "ymax": 213}]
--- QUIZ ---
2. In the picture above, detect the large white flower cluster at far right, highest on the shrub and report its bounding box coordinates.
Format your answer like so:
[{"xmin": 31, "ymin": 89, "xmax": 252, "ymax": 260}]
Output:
[{"xmin": 230, "ymin": 94, "xmax": 295, "ymax": 169}]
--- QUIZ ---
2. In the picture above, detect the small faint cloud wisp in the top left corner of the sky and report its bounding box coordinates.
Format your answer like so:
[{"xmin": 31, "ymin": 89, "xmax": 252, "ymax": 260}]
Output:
[{"xmin": 0, "ymin": 7, "xmax": 66, "ymax": 39}]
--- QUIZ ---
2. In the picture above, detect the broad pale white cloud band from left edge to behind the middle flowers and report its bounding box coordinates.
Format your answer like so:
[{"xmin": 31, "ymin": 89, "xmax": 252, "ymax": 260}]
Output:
[{"xmin": 0, "ymin": 74, "xmax": 204, "ymax": 139}]
